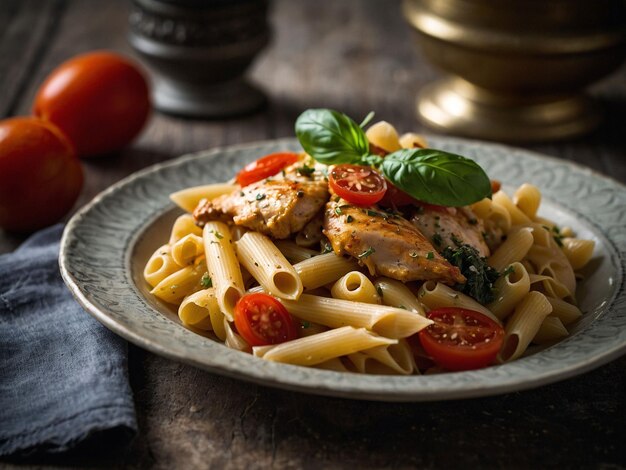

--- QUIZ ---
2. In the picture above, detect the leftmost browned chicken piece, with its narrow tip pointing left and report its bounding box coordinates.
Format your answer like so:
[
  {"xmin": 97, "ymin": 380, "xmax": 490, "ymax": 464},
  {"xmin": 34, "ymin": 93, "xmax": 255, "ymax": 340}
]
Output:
[{"xmin": 193, "ymin": 179, "xmax": 328, "ymax": 239}]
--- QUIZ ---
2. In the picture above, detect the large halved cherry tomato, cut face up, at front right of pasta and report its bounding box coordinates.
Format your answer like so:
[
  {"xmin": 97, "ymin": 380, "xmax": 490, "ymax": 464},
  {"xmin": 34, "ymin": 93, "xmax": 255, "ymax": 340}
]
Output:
[{"xmin": 419, "ymin": 307, "xmax": 504, "ymax": 371}]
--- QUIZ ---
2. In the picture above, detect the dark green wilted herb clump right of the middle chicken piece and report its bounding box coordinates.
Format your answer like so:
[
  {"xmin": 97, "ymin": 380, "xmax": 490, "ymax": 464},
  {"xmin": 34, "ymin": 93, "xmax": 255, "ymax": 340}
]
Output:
[{"xmin": 441, "ymin": 241, "xmax": 500, "ymax": 305}]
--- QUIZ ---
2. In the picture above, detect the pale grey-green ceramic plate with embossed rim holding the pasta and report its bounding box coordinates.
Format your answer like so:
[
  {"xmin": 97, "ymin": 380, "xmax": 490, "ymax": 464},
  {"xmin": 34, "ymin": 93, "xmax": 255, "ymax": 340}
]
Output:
[{"xmin": 60, "ymin": 137, "xmax": 626, "ymax": 401}]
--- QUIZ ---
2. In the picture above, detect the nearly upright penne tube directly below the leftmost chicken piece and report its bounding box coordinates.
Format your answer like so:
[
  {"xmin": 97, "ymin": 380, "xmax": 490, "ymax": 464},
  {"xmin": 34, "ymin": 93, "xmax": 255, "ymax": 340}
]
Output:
[{"xmin": 202, "ymin": 222, "xmax": 244, "ymax": 321}]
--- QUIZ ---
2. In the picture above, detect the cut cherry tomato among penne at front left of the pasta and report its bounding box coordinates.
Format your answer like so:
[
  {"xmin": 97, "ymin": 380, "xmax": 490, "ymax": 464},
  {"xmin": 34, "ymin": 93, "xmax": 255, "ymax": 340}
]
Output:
[{"xmin": 235, "ymin": 294, "xmax": 298, "ymax": 346}]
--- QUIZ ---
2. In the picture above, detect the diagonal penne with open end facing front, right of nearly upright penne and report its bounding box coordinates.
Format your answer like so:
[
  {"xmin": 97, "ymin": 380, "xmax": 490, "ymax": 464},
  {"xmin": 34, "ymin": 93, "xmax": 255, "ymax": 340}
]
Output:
[{"xmin": 235, "ymin": 232, "xmax": 303, "ymax": 299}]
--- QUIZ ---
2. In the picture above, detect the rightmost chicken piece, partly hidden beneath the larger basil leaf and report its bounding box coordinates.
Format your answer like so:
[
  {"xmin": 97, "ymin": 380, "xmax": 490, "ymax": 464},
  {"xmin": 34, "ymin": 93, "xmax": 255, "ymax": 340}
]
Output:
[{"xmin": 410, "ymin": 207, "xmax": 489, "ymax": 257}]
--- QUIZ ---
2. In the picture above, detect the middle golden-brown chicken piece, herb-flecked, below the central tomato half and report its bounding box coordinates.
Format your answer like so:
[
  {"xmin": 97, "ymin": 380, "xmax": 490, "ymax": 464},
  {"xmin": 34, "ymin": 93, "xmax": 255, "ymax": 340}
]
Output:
[{"xmin": 324, "ymin": 198, "xmax": 465, "ymax": 285}]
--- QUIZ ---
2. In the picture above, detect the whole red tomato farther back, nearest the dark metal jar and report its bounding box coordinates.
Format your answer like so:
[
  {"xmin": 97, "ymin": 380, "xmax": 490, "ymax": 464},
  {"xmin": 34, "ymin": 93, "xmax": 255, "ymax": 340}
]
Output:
[{"xmin": 33, "ymin": 52, "xmax": 150, "ymax": 156}]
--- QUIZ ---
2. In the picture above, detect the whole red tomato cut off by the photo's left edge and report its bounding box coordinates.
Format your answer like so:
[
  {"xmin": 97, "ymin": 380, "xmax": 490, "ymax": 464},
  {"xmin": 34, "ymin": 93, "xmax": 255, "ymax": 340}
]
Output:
[{"xmin": 0, "ymin": 118, "xmax": 83, "ymax": 232}]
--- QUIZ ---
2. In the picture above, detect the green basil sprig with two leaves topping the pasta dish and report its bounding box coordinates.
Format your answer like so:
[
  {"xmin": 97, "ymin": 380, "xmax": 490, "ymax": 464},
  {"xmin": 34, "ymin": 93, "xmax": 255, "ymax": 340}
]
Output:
[{"xmin": 296, "ymin": 109, "xmax": 491, "ymax": 207}]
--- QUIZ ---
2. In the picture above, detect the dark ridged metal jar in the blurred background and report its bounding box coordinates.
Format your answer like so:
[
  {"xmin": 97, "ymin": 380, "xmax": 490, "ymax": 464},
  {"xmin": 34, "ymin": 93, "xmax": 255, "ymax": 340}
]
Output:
[{"xmin": 129, "ymin": 0, "xmax": 270, "ymax": 117}]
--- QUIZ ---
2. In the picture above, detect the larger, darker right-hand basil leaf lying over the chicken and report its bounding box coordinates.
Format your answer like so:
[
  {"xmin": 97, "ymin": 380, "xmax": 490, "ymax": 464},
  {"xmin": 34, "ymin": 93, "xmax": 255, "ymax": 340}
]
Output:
[{"xmin": 381, "ymin": 149, "xmax": 491, "ymax": 207}]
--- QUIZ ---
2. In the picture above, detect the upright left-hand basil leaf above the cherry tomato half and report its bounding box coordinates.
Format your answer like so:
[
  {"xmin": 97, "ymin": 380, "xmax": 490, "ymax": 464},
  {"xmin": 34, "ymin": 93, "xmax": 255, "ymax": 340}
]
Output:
[{"xmin": 296, "ymin": 109, "xmax": 369, "ymax": 165}]
